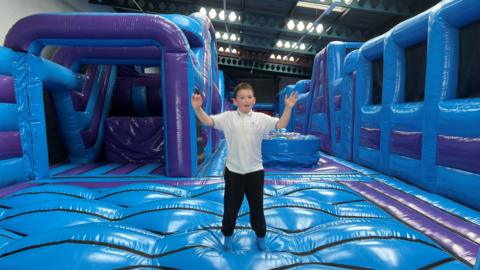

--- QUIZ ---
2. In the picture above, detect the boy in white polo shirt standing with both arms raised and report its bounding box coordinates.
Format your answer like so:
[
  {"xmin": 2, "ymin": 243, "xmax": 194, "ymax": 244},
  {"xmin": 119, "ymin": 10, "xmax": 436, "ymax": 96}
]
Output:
[{"xmin": 192, "ymin": 83, "xmax": 297, "ymax": 251}]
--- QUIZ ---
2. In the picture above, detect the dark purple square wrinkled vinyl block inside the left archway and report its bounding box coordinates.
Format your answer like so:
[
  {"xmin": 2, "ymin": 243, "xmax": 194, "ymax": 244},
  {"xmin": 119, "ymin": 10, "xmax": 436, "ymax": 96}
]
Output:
[{"xmin": 104, "ymin": 117, "xmax": 165, "ymax": 163}]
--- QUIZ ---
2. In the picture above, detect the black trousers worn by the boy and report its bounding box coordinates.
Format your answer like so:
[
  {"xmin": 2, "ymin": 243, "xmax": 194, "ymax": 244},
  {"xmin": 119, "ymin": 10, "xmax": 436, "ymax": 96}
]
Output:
[{"xmin": 222, "ymin": 167, "xmax": 267, "ymax": 237}]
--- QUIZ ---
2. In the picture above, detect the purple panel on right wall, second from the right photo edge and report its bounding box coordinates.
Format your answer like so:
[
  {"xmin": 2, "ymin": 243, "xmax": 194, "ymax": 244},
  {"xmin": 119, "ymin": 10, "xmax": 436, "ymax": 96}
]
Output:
[{"xmin": 390, "ymin": 130, "xmax": 422, "ymax": 160}]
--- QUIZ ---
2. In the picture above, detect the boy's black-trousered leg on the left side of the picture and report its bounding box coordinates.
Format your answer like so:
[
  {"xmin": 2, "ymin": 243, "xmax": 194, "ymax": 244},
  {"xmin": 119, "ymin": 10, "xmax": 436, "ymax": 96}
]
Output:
[{"xmin": 222, "ymin": 168, "xmax": 245, "ymax": 236}]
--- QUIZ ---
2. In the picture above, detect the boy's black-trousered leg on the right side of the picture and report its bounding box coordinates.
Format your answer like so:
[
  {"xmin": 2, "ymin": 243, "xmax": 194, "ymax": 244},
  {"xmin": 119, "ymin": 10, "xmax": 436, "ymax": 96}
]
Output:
[{"xmin": 245, "ymin": 170, "xmax": 267, "ymax": 238}]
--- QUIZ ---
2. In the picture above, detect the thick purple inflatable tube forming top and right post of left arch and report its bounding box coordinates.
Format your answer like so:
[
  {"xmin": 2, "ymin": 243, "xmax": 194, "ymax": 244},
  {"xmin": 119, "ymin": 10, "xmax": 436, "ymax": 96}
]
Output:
[{"xmin": 4, "ymin": 13, "xmax": 196, "ymax": 176}]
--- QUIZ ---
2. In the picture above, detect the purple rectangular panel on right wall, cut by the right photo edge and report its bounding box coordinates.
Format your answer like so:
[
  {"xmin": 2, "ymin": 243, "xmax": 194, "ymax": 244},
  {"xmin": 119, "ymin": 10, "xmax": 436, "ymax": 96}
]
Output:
[{"xmin": 437, "ymin": 135, "xmax": 480, "ymax": 174}]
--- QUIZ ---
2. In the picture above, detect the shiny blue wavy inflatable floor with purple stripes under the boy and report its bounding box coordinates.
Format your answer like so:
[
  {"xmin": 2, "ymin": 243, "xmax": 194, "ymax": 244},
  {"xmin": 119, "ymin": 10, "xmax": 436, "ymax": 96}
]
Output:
[{"xmin": 0, "ymin": 143, "xmax": 480, "ymax": 269}]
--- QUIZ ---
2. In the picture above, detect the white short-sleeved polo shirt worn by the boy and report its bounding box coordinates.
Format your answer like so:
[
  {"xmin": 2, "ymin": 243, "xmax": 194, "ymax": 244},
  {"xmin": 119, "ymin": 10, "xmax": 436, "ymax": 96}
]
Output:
[{"xmin": 210, "ymin": 111, "xmax": 279, "ymax": 174}]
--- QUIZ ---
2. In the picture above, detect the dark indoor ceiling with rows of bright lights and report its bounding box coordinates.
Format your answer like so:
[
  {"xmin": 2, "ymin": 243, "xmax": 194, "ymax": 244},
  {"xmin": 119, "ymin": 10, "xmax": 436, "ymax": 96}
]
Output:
[{"xmin": 89, "ymin": 0, "xmax": 440, "ymax": 77}]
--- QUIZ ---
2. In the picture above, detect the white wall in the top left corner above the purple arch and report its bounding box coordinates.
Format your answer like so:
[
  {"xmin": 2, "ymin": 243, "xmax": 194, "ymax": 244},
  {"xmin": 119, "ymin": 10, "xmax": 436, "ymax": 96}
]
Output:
[{"xmin": 0, "ymin": 0, "xmax": 114, "ymax": 44}]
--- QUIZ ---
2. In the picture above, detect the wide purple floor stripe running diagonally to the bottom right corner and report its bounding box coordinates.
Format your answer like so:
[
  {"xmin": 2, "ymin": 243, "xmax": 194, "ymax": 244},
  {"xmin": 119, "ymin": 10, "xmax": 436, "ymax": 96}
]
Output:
[{"xmin": 342, "ymin": 181, "xmax": 478, "ymax": 265}]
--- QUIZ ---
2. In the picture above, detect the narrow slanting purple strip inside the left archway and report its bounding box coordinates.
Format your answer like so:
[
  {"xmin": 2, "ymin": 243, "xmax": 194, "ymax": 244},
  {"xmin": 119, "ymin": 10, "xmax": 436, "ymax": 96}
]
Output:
[{"xmin": 81, "ymin": 66, "xmax": 112, "ymax": 148}]
